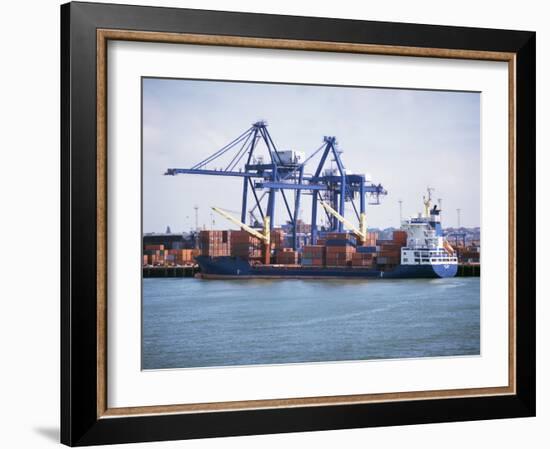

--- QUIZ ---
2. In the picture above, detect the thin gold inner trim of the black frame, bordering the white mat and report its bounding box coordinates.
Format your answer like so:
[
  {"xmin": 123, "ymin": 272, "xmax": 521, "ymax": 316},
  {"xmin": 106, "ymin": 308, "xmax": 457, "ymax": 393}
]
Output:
[{"xmin": 96, "ymin": 29, "xmax": 516, "ymax": 418}]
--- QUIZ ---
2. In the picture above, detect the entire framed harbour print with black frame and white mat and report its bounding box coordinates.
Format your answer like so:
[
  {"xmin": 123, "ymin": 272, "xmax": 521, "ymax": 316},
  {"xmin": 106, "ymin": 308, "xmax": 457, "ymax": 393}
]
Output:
[{"xmin": 61, "ymin": 3, "xmax": 535, "ymax": 446}]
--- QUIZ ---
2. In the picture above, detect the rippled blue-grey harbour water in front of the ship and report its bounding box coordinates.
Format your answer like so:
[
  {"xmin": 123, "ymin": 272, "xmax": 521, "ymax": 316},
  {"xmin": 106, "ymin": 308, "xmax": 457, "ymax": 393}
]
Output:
[{"xmin": 142, "ymin": 277, "xmax": 480, "ymax": 369}]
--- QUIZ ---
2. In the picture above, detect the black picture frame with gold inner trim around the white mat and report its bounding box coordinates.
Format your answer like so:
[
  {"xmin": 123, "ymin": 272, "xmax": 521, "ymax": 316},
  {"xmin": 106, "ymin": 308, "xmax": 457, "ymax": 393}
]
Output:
[{"xmin": 61, "ymin": 3, "xmax": 536, "ymax": 446}]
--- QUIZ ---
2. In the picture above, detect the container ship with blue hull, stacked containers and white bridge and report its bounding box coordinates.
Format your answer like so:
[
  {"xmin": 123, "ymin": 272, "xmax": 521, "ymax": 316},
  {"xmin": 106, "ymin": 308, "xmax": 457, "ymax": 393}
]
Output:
[{"xmin": 195, "ymin": 190, "xmax": 458, "ymax": 279}]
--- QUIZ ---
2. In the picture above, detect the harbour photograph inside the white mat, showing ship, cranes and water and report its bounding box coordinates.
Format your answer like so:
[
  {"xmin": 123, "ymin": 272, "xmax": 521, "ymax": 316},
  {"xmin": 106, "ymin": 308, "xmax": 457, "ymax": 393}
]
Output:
[{"xmin": 140, "ymin": 77, "xmax": 484, "ymax": 370}]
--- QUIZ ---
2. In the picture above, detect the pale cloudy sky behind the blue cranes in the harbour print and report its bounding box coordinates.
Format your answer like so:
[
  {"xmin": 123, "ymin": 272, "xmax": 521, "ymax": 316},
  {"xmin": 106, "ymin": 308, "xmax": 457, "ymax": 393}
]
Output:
[{"xmin": 142, "ymin": 78, "xmax": 481, "ymax": 232}]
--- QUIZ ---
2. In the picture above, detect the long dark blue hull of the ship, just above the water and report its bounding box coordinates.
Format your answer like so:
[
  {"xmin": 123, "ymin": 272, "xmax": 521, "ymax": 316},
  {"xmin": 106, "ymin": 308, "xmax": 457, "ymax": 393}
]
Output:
[{"xmin": 195, "ymin": 256, "xmax": 458, "ymax": 279}]
